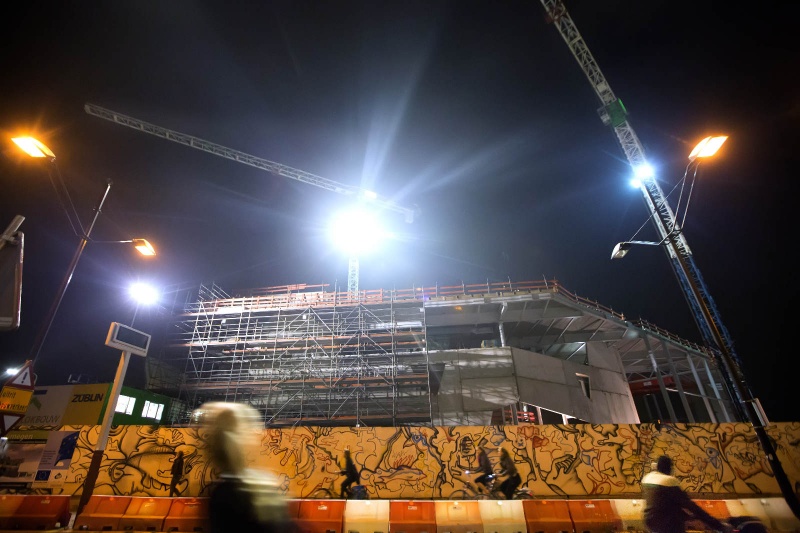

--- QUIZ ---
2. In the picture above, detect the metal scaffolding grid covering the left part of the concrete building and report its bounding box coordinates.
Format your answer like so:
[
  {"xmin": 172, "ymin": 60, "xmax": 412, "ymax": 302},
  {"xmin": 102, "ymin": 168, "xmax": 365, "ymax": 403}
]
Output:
[{"xmin": 154, "ymin": 285, "xmax": 440, "ymax": 426}]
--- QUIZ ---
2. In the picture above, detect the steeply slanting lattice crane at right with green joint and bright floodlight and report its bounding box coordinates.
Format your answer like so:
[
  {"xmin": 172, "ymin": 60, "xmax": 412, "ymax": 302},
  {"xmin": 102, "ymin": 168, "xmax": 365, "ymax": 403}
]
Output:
[{"xmin": 541, "ymin": 0, "xmax": 741, "ymax": 382}]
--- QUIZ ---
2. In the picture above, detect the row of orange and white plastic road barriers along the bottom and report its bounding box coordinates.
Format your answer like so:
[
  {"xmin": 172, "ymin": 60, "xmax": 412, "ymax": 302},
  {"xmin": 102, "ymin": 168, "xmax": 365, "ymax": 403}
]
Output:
[{"xmin": 0, "ymin": 495, "xmax": 800, "ymax": 533}]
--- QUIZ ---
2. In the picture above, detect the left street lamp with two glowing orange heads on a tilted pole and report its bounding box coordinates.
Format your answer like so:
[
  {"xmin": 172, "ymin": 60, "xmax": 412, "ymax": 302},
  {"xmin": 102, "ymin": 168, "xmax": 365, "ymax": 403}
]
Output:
[{"xmin": 11, "ymin": 137, "xmax": 155, "ymax": 363}]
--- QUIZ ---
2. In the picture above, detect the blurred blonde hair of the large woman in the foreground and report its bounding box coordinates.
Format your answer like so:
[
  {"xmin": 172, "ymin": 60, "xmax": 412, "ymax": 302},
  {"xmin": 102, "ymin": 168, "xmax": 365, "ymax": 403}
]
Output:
[{"xmin": 194, "ymin": 402, "xmax": 263, "ymax": 475}]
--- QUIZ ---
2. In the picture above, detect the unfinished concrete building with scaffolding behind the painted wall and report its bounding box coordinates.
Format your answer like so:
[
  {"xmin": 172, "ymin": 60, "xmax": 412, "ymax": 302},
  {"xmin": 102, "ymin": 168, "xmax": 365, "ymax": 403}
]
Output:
[{"xmin": 148, "ymin": 281, "xmax": 736, "ymax": 426}]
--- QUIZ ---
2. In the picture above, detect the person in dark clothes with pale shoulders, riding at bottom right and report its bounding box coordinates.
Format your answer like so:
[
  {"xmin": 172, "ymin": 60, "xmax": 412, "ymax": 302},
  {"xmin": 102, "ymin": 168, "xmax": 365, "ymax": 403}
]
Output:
[{"xmin": 642, "ymin": 455, "xmax": 732, "ymax": 533}]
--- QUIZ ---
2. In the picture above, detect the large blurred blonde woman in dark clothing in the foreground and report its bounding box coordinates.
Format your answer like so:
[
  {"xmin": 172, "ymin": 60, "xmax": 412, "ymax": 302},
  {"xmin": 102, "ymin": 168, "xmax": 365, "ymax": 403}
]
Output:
[{"xmin": 197, "ymin": 402, "xmax": 294, "ymax": 533}]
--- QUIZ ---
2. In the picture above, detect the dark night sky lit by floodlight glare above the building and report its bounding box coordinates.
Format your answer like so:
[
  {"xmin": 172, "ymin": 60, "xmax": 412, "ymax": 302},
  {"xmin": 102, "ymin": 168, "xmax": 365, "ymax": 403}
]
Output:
[{"xmin": 0, "ymin": 0, "xmax": 800, "ymax": 421}]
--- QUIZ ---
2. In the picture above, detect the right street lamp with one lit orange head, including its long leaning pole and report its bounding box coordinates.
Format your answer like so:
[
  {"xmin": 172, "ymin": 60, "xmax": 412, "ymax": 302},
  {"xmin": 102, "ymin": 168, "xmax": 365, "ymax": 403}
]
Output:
[{"xmin": 611, "ymin": 135, "xmax": 800, "ymax": 516}]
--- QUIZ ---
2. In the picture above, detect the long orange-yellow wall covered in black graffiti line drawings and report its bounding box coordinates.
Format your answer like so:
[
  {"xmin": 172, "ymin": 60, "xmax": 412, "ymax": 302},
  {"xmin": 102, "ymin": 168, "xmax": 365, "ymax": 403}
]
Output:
[{"xmin": 0, "ymin": 422, "xmax": 800, "ymax": 499}]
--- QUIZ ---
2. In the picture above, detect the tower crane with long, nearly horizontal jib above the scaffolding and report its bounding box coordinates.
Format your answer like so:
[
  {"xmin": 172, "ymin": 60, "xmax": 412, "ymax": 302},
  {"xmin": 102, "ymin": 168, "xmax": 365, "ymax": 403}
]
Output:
[{"xmin": 83, "ymin": 103, "xmax": 419, "ymax": 296}]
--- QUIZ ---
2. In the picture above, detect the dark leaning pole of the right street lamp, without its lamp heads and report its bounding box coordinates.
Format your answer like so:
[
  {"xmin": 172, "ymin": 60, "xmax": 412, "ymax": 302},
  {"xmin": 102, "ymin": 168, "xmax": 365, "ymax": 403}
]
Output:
[{"xmin": 644, "ymin": 187, "xmax": 800, "ymax": 517}]
